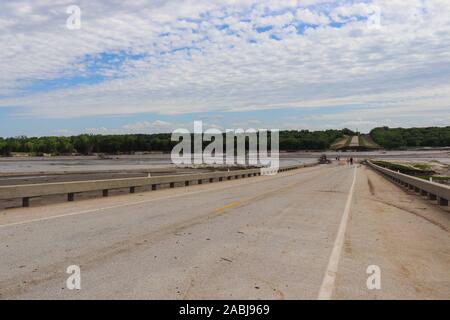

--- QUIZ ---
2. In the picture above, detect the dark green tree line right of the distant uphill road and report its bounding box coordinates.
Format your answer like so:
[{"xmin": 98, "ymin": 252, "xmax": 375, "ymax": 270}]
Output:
[{"xmin": 370, "ymin": 126, "xmax": 450, "ymax": 149}]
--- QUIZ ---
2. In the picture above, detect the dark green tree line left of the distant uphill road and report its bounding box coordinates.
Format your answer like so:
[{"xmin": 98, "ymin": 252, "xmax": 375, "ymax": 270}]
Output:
[{"xmin": 0, "ymin": 129, "xmax": 353, "ymax": 156}]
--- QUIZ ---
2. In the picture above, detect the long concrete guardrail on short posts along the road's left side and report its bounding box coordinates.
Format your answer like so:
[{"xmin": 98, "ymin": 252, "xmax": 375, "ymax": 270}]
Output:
[{"xmin": 0, "ymin": 164, "xmax": 315, "ymax": 207}]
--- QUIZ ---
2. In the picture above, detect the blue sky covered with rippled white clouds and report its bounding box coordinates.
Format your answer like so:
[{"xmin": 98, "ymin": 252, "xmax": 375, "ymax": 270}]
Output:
[{"xmin": 0, "ymin": 0, "xmax": 450, "ymax": 137}]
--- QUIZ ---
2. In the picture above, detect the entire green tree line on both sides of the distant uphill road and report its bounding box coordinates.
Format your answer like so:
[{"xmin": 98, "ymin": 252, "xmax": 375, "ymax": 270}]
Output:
[{"xmin": 0, "ymin": 126, "xmax": 450, "ymax": 156}]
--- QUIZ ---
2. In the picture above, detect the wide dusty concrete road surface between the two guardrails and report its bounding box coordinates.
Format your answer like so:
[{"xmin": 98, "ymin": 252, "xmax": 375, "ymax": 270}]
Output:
[{"xmin": 0, "ymin": 164, "xmax": 450, "ymax": 299}]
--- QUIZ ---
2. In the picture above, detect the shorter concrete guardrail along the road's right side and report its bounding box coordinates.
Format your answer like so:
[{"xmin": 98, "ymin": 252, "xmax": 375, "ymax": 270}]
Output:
[{"xmin": 367, "ymin": 161, "xmax": 450, "ymax": 206}]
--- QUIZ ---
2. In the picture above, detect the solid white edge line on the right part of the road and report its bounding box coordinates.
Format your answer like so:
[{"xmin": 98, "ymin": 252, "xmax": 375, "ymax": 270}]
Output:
[{"xmin": 317, "ymin": 166, "xmax": 357, "ymax": 300}]
